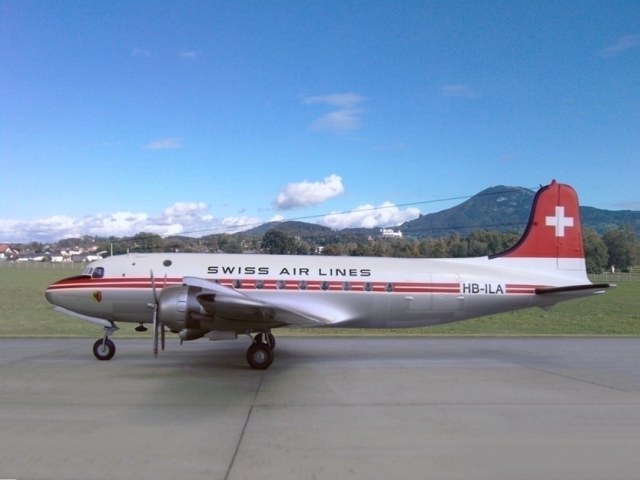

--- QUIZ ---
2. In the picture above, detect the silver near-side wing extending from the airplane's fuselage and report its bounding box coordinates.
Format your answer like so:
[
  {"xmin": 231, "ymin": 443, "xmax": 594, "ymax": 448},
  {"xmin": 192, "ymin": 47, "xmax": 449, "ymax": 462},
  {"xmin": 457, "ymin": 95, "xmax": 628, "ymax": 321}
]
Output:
[{"xmin": 183, "ymin": 277, "xmax": 346, "ymax": 328}]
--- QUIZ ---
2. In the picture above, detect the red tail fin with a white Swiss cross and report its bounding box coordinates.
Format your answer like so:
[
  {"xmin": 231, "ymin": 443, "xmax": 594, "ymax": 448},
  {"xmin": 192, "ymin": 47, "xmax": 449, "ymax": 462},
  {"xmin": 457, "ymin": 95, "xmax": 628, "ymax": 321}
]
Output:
[{"xmin": 498, "ymin": 180, "xmax": 584, "ymax": 258}]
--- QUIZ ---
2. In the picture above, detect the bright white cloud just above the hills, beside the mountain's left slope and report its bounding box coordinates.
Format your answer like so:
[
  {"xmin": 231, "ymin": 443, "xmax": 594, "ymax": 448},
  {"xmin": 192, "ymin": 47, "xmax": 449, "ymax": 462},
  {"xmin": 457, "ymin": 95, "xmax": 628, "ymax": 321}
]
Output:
[{"xmin": 318, "ymin": 202, "xmax": 420, "ymax": 230}]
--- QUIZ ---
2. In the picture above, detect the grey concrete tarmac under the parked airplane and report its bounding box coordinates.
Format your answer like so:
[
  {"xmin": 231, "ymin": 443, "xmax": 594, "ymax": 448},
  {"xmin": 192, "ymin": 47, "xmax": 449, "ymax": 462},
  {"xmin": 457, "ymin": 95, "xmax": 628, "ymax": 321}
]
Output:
[{"xmin": 0, "ymin": 335, "xmax": 640, "ymax": 480}]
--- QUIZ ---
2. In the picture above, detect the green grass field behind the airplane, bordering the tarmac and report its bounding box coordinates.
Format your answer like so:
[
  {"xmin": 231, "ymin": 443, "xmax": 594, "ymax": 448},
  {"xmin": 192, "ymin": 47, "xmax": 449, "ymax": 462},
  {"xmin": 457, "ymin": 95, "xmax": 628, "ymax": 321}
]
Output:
[{"xmin": 0, "ymin": 263, "xmax": 640, "ymax": 337}]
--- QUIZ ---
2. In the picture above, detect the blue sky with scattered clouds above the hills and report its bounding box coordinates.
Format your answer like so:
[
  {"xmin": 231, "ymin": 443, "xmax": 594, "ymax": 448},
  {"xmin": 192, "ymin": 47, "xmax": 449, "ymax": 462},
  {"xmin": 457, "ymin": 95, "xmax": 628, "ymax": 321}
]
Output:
[{"xmin": 0, "ymin": 0, "xmax": 640, "ymax": 242}]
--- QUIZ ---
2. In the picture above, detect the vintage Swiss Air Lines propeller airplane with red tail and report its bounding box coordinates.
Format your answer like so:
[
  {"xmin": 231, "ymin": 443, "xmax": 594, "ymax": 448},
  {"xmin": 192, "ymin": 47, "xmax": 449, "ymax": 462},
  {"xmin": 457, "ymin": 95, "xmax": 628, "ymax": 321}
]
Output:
[{"xmin": 45, "ymin": 180, "xmax": 613, "ymax": 370}]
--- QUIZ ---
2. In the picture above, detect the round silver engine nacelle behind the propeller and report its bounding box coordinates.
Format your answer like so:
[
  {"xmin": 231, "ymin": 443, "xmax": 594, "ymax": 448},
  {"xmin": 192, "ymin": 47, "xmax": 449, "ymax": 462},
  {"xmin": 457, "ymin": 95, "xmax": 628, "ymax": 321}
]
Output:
[{"xmin": 158, "ymin": 285, "xmax": 207, "ymax": 332}]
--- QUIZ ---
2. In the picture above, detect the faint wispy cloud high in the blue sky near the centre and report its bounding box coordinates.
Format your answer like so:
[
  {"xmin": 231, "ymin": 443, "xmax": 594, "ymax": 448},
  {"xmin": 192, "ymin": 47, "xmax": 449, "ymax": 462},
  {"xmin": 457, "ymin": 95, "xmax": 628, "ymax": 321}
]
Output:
[{"xmin": 303, "ymin": 93, "xmax": 366, "ymax": 133}]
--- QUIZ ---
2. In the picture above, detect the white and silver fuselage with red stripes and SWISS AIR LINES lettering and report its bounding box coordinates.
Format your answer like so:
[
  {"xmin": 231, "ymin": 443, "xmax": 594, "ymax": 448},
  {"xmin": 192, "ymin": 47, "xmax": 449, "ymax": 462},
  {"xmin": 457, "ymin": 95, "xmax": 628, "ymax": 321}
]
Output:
[{"xmin": 46, "ymin": 253, "xmax": 588, "ymax": 329}]
